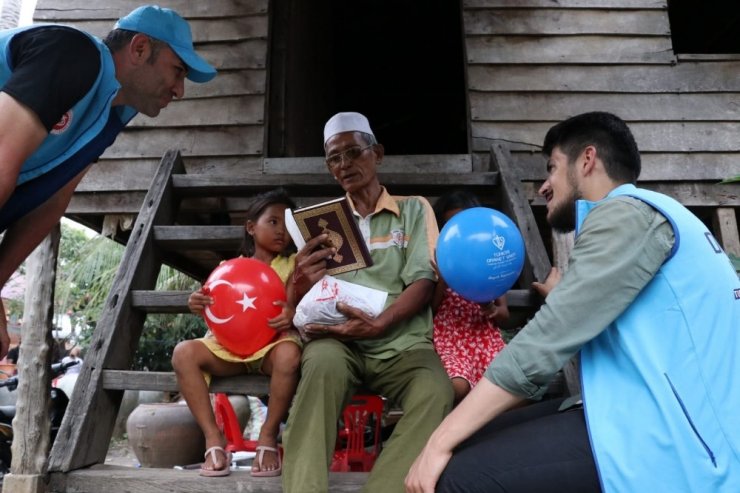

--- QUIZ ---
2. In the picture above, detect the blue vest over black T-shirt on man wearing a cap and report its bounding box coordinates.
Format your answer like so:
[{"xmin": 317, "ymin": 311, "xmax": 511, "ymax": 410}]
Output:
[{"xmin": 0, "ymin": 25, "xmax": 136, "ymax": 231}]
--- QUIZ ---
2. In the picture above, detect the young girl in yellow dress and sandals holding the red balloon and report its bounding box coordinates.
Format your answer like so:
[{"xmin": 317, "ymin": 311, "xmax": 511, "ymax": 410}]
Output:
[{"xmin": 172, "ymin": 190, "xmax": 301, "ymax": 476}]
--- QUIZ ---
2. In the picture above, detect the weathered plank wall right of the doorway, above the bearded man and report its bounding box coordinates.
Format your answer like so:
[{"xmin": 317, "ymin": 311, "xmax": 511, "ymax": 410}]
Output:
[{"xmin": 463, "ymin": 0, "xmax": 740, "ymax": 189}]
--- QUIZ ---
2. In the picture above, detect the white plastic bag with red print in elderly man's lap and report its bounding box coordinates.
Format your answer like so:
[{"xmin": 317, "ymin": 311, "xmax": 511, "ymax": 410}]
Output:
[{"xmin": 293, "ymin": 276, "xmax": 388, "ymax": 339}]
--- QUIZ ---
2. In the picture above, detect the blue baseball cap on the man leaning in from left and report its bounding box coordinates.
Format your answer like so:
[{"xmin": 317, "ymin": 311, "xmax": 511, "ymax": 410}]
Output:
[{"xmin": 114, "ymin": 5, "xmax": 216, "ymax": 82}]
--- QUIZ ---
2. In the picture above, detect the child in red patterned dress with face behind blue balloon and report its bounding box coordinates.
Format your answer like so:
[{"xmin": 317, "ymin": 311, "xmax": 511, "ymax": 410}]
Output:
[{"xmin": 432, "ymin": 191, "xmax": 509, "ymax": 402}]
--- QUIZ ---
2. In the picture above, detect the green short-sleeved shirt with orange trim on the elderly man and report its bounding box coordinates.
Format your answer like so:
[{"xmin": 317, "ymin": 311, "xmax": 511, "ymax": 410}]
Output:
[{"xmin": 335, "ymin": 188, "xmax": 439, "ymax": 359}]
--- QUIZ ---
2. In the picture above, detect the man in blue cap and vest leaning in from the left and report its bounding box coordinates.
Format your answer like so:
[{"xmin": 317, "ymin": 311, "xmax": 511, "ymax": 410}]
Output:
[{"xmin": 0, "ymin": 5, "xmax": 216, "ymax": 358}]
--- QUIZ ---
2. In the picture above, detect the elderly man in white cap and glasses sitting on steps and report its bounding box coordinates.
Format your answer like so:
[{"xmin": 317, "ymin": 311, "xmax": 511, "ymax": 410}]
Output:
[{"xmin": 283, "ymin": 113, "xmax": 453, "ymax": 493}]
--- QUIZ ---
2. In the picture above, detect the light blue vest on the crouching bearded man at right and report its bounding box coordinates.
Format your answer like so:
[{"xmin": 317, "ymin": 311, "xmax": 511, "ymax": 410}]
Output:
[{"xmin": 576, "ymin": 185, "xmax": 740, "ymax": 493}]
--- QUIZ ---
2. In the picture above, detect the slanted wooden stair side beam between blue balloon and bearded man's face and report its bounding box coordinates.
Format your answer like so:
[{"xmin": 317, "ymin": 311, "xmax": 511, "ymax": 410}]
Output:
[{"xmin": 491, "ymin": 144, "xmax": 551, "ymax": 287}]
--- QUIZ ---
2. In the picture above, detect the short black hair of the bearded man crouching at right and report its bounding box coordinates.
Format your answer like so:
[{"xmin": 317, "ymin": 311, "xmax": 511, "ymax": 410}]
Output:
[{"xmin": 542, "ymin": 111, "xmax": 642, "ymax": 183}]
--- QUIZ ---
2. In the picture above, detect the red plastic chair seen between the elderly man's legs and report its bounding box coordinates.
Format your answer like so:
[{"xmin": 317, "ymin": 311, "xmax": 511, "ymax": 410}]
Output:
[{"xmin": 330, "ymin": 395, "xmax": 383, "ymax": 472}]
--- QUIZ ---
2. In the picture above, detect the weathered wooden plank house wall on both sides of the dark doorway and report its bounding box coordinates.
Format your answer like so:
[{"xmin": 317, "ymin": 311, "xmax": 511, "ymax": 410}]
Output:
[{"xmin": 34, "ymin": 0, "xmax": 740, "ymax": 212}]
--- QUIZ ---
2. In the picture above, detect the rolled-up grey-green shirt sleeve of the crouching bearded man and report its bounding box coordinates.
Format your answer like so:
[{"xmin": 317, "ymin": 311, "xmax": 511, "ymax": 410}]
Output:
[{"xmin": 485, "ymin": 197, "xmax": 674, "ymax": 399}]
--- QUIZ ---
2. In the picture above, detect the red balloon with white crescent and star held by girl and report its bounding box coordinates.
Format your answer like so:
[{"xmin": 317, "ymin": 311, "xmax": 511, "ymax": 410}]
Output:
[{"xmin": 203, "ymin": 258, "xmax": 287, "ymax": 357}]
